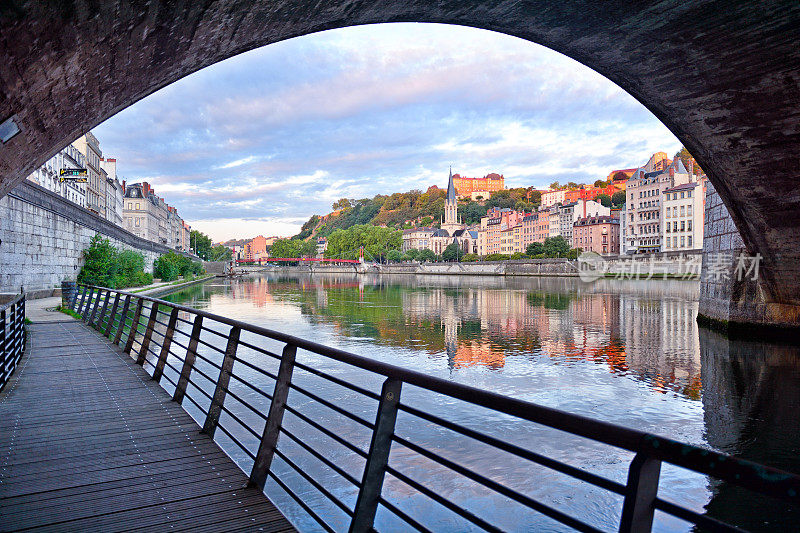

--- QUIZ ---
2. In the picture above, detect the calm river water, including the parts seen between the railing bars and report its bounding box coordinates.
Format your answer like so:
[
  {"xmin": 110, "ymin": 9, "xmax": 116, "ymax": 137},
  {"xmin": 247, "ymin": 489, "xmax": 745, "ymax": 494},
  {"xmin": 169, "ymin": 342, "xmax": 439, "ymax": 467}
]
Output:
[{"xmin": 159, "ymin": 274, "xmax": 800, "ymax": 531}]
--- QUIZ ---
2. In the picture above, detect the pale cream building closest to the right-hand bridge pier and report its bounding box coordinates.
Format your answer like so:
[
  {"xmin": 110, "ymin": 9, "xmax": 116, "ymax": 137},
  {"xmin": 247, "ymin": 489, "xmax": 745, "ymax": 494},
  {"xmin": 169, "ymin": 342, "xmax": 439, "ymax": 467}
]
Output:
[{"xmin": 661, "ymin": 180, "xmax": 706, "ymax": 252}]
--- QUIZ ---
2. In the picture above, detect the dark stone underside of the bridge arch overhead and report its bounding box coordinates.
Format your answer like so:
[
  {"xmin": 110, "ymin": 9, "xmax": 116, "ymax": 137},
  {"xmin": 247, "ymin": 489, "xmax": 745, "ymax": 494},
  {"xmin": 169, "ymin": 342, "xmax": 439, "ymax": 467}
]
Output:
[{"xmin": 0, "ymin": 0, "xmax": 800, "ymax": 324}]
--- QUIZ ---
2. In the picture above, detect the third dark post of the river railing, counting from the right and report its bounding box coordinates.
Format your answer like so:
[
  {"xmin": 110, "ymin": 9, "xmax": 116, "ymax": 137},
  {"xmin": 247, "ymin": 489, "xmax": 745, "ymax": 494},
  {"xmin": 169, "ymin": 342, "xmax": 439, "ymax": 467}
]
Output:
[{"xmin": 250, "ymin": 344, "xmax": 297, "ymax": 490}]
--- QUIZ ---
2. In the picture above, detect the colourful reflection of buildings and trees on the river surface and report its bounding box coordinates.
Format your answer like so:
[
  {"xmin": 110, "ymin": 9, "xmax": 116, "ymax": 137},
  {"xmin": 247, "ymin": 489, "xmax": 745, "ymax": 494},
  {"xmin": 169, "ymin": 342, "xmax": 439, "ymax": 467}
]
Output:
[{"xmin": 248, "ymin": 274, "xmax": 702, "ymax": 400}]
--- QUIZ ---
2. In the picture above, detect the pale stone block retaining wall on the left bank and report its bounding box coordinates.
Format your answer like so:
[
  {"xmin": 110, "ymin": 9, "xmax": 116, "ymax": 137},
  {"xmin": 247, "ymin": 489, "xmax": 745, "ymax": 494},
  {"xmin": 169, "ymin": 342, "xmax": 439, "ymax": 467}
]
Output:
[{"xmin": 0, "ymin": 181, "xmax": 197, "ymax": 293}]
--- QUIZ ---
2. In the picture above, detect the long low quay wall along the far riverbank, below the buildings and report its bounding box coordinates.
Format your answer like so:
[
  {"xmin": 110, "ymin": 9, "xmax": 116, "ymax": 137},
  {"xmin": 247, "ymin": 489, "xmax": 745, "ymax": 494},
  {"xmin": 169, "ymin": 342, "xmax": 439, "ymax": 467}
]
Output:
[{"xmin": 248, "ymin": 250, "xmax": 702, "ymax": 279}]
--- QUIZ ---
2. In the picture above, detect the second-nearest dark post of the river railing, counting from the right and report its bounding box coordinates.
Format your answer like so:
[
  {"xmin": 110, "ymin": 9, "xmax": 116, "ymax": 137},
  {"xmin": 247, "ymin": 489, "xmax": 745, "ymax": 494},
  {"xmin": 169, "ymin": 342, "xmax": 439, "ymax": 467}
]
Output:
[{"xmin": 350, "ymin": 378, "xmax": 403, "ymax": 533}]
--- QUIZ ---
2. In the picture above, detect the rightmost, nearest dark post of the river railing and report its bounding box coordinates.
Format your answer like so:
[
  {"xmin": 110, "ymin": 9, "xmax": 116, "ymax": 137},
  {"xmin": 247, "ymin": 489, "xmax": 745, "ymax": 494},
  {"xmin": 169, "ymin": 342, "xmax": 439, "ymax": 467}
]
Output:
[{"xmin": 619, "ymin": 452, "xmax": 661, "ymax": 533}]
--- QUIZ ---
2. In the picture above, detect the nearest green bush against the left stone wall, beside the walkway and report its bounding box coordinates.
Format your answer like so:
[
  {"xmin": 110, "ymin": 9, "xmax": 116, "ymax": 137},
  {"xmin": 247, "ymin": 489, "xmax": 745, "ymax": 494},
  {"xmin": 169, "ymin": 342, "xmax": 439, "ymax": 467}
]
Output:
[{"xmin": 78, "ymin": 234, "xmax": 153, "ymax": 289}]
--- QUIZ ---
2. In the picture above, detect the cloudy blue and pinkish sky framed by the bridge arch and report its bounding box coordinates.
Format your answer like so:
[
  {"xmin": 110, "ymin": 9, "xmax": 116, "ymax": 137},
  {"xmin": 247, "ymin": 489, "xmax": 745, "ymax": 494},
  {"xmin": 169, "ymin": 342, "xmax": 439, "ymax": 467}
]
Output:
[{"xmin": 93, "ymin": 24, "xmax": 680, "ymax": 241}]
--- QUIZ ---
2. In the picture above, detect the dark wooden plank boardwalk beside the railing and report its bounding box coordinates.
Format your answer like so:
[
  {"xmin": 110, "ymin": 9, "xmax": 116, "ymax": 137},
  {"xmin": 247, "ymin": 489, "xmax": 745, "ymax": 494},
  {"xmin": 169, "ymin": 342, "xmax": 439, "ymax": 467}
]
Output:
[{"xmin": 0, "ymin": 319, "xmax": 294, "ymax": 532}]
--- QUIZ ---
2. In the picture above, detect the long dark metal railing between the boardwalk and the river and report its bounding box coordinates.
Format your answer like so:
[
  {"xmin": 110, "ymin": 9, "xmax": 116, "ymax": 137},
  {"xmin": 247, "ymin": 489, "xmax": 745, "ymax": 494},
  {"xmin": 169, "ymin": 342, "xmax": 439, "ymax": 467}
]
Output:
[{"xmin": 72, "ymin": 284, "xmax": 800, "ymax": 531}]
